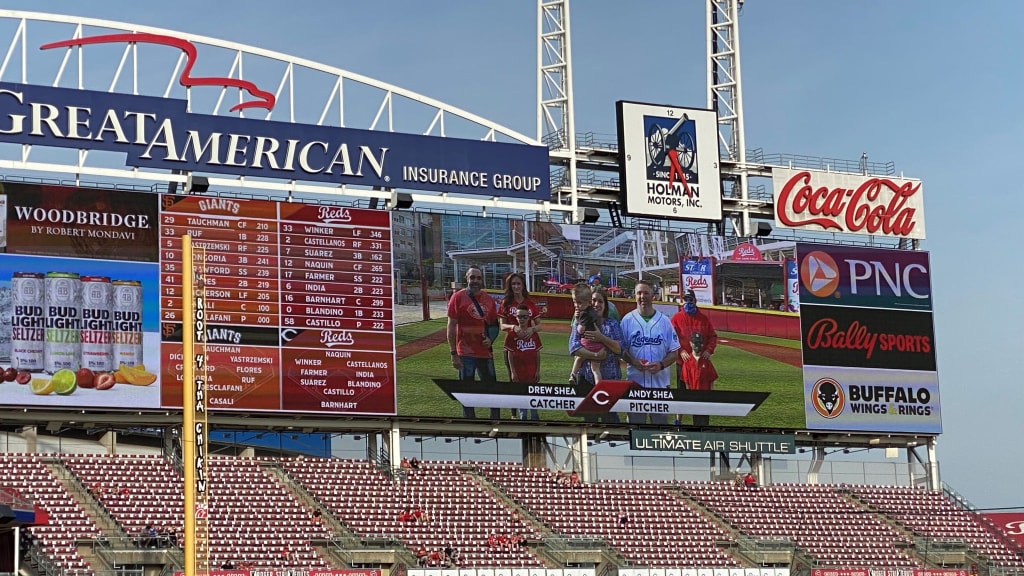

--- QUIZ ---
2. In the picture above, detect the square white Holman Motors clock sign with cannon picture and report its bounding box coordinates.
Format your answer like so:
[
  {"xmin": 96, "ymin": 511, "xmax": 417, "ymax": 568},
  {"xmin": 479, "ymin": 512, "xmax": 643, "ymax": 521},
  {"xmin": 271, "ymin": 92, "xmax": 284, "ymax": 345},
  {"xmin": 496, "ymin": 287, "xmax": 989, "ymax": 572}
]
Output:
[{"xmin": 615, "ymin": 100, "xmax": 722, "ymax": 221}]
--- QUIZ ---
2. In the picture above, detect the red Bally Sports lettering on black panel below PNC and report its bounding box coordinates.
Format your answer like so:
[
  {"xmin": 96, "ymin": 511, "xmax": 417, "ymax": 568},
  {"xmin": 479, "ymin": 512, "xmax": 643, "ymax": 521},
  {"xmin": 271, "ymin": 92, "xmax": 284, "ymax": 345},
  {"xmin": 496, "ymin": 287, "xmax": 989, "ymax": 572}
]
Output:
[{"xmin": 804, "ymin": 318, "xmax": 932, "ymax": 360}]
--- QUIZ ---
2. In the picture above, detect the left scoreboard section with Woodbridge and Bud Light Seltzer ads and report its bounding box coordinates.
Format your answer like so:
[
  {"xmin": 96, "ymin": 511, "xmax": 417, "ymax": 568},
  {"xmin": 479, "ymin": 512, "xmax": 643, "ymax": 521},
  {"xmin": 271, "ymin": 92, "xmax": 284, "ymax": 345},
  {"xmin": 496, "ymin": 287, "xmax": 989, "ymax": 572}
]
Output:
[{"xmin": 0, "ymin": 182, "xmax": 160, "ymax": 408}]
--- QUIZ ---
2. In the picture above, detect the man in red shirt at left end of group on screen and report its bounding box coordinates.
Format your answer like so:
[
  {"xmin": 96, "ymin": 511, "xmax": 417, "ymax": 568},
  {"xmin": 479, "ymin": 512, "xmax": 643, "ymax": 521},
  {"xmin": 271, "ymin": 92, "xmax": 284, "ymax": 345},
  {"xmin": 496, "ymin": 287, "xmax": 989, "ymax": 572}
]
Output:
[{"xmin": 447, "ymin": 265, "xmax": 501, "ymax": 420}]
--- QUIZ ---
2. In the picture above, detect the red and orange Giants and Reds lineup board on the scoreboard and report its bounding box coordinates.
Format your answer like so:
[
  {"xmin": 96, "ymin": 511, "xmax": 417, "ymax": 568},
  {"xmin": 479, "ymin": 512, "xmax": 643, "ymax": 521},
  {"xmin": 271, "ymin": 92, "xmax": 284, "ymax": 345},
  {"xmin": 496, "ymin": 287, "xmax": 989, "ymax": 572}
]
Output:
[{"xmin": 160, "ymin": 196, "xmax": 395, "ymax": 414}]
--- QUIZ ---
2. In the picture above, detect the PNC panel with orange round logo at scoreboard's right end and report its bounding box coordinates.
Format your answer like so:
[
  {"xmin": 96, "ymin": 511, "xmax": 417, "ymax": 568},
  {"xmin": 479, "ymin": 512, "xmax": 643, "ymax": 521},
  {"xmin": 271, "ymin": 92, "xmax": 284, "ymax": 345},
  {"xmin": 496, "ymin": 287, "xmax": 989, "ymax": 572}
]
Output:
[{"xmin": 797, "ymin": 244, "xmax": 932, "ymax": 311}]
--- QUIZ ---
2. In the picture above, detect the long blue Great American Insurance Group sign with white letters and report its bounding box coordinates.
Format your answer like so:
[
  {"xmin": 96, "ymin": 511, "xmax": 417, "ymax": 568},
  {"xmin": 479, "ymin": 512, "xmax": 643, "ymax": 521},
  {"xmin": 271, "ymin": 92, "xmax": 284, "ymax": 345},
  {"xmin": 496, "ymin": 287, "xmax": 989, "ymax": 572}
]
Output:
[{"xmin": 0, "ymin": 82, "xmax": 551, "ymax": 200}]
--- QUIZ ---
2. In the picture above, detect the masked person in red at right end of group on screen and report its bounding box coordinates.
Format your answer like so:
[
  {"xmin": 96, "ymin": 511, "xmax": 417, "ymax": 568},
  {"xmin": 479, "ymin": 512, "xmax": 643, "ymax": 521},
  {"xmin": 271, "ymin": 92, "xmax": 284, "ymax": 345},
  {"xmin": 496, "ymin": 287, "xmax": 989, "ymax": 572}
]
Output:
[{"xmin": 672, "ymin": 290, "xmax": 718, "ymax": 426}]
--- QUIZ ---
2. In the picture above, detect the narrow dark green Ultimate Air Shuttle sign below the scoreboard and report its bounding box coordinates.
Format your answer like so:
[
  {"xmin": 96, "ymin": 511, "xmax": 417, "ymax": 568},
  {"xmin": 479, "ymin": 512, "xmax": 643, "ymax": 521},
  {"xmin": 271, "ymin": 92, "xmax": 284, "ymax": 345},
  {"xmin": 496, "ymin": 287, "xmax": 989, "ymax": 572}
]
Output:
[{"xmin": 630, "ymin": 430, "xmax": 797, "ymax": 454}]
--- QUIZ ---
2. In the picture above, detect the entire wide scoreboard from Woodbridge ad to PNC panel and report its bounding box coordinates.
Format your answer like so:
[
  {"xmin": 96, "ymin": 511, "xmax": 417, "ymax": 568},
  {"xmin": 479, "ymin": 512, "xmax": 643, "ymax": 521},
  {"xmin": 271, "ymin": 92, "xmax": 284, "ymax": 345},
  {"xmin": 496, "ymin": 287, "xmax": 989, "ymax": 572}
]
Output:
[{"xmin": 0, "ymin": 196, "xmax": 941, "ymax": 434}]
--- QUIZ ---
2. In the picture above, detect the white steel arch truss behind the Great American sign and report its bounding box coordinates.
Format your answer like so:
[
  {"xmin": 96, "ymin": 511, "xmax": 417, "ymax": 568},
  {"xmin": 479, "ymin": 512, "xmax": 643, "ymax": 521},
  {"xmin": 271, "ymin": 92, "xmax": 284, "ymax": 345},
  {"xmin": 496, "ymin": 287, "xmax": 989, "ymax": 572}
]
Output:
[{"xmin": 0, "ymin": 9, "xmax": 557, "ymax": 212}]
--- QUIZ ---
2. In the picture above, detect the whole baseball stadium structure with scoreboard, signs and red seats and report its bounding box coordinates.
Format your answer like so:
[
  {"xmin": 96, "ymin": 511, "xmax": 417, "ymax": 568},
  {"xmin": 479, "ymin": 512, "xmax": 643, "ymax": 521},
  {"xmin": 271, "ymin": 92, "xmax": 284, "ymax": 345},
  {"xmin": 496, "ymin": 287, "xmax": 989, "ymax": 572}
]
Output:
[{"xmin": 0, "ymin": 5, "xmax": 1024, "ymax": 576}]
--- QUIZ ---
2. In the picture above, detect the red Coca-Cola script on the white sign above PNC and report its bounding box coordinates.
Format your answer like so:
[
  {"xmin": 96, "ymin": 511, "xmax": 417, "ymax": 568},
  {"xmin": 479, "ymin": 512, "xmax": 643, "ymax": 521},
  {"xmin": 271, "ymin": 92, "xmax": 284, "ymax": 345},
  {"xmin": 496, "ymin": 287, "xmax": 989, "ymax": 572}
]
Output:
[{"xmin": 775, "ymin": 170, "xmax": 921, "ymax": 237}]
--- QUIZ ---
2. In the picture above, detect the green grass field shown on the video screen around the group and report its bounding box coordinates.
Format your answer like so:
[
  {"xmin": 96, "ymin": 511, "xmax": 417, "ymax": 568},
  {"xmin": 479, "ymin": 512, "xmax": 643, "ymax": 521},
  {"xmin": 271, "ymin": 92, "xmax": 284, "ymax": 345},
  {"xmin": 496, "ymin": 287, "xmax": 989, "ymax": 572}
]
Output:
[{"xmin": 395, "ymin": 320, "xmax": 805, "ymax": 428}]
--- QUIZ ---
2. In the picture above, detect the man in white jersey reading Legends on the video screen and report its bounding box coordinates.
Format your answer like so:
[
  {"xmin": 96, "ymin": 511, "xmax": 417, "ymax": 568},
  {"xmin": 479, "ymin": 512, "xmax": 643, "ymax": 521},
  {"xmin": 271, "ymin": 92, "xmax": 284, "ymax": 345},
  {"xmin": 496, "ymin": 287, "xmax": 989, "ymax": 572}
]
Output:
[{"xmin": 620, "ymin": 281, "xmax": 679, "ymax": 424}]
